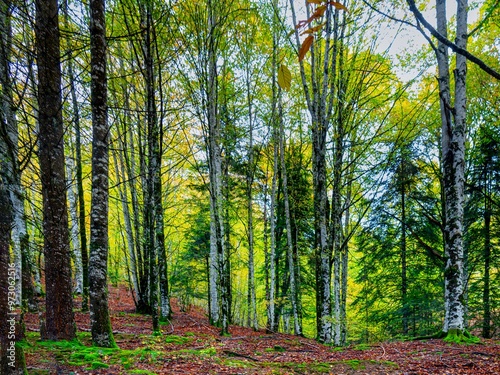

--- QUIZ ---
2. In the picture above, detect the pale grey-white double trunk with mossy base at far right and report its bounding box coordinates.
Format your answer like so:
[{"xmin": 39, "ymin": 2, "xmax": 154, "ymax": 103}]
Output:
[{"xmin": 436, "ymin": 0, "xmax": 467, "ymax": 336}]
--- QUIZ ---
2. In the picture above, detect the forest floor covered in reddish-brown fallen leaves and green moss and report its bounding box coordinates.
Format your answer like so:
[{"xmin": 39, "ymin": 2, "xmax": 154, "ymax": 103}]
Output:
[{"xmin": 24, "ymin": 286, "xmax": 500, "ymax": 375}]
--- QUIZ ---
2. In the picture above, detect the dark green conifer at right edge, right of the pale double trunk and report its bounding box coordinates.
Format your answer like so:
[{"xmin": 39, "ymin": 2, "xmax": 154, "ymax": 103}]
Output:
[{"xmin": 465, "ymin": 125, "xmax": 500, "ymax": 338}]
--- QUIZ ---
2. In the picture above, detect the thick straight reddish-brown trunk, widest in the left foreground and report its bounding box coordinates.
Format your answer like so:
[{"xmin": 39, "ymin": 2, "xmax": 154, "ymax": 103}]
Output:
[{"xmin": 35, "ymin": 0, "xmax": 76, "ymax": 340}]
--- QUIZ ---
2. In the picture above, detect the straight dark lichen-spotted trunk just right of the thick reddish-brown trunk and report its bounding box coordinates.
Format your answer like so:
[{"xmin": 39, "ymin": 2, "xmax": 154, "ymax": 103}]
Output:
[{"xmin": 89, "ymin": 0, "xmax": 116, "ymax": 347}]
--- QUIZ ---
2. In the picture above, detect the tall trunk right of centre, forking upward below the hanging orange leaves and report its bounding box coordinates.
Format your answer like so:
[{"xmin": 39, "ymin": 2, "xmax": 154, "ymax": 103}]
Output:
[{"xmin": 290, "ymin": 0, "xmax": 338, "ymax": 343}]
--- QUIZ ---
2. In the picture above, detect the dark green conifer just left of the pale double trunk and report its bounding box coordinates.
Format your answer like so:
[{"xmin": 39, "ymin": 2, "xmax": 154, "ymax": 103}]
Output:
[{"xmin": 354, "ymin": 145, "xmax": 443, "ymax": 341}]
